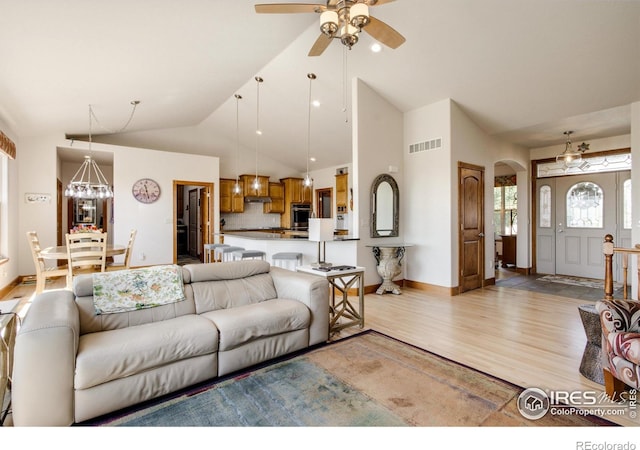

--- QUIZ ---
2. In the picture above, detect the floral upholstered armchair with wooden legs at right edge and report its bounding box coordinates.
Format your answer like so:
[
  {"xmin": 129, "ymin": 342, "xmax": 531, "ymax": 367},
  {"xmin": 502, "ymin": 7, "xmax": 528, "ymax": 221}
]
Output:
[{"xmin": 596, "ymin": 299, "xmax": 640, "ymax": 400}]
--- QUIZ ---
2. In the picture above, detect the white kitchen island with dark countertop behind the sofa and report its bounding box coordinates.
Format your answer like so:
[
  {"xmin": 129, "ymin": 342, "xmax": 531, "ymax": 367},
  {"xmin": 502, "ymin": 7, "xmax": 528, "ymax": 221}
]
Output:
[{"xmin": 218, "ymin": 229, "xmax": 358, "ymax": 266}]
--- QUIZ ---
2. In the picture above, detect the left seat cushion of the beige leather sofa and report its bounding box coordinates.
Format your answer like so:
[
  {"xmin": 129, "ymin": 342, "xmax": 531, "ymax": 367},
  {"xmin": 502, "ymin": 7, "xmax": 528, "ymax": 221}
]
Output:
[{"xmin": 74, "ymin": 315, "xmax": 218, "ymax": 389}]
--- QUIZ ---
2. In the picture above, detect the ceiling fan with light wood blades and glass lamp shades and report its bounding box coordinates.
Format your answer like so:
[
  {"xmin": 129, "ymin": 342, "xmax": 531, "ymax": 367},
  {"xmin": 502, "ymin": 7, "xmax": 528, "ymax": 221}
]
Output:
[{"xmin": 255, "ymin": 0, "xmax": 405, "ymax": 56}]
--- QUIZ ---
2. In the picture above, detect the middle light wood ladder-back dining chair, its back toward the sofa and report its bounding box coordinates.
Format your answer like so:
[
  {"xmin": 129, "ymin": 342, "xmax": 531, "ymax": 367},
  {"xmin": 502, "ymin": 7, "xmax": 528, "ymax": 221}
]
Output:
[{"xmin": 67, "ymin": 233, "xmax": 107, "ymax": 285}]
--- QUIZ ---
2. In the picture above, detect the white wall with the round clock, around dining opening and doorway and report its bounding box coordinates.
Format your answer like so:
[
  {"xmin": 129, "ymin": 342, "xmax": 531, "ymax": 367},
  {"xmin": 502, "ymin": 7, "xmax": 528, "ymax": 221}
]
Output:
[{"xmin": 17, "ymin": 136, "xmax": 219, "ymax": 275}]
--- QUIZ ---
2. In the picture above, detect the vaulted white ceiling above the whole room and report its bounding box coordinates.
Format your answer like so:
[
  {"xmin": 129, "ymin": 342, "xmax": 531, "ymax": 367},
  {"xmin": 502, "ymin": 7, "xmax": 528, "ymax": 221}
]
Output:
[{"xmin": 0, "ymin": 0, "xmax": 640, "ymax": 169}]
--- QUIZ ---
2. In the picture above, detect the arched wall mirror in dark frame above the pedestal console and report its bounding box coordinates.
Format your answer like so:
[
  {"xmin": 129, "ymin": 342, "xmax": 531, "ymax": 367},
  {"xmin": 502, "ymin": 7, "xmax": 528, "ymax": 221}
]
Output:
[{"xmin": 371, "ymin": 173, "xmax": 399, "ymax": 237}]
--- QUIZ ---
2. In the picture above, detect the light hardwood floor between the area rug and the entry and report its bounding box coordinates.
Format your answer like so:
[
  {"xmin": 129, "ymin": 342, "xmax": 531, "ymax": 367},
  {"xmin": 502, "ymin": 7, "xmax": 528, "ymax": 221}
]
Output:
[{"xmin": 5, "ymin": 274, "xmax": 640, "ymax": 426}]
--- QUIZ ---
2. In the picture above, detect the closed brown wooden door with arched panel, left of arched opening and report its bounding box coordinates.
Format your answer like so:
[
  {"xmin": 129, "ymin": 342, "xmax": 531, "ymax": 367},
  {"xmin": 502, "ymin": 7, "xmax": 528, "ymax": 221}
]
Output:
[{"xmin": 458, "ymin": 163, "xmax": 484, "ymax": 293}]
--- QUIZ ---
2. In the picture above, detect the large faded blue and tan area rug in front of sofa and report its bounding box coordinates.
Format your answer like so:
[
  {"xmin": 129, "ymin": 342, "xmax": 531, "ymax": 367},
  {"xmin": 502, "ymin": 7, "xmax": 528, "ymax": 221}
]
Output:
[{"xmin": 84, "ymin": 331, "xmax": 611, "ymax": 427}]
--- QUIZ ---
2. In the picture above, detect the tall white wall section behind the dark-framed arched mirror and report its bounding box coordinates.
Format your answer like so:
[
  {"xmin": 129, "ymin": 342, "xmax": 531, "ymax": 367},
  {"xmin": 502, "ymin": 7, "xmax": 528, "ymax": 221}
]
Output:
[{"xmin": 349, "ymin": 78, "xmax": 408, "ymax": 286}]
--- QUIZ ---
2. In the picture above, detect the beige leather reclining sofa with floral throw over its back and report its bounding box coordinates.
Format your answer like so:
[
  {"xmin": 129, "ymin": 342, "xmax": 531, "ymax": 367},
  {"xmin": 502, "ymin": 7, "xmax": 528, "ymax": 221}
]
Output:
[{"xmin": 12, "ymin": 260, "xmax": 329, "ymax": 426}]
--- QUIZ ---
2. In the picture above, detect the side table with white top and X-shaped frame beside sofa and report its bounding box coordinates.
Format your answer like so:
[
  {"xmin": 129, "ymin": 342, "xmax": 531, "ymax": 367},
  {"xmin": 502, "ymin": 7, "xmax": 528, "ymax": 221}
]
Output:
[{"xmin": 296, "ymin": 266, "xmax": 364, "ymax": 335}]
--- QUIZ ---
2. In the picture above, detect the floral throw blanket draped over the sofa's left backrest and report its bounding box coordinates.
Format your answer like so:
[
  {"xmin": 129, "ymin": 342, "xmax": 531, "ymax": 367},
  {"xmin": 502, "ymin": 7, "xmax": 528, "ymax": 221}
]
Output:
[{"xmin": 93, "ymin": 265, "xmax": 185, "ymax": 314}]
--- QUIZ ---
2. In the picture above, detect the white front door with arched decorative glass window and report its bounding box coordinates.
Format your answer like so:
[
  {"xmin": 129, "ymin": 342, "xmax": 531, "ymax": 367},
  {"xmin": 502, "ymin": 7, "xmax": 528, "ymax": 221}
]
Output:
[{"xmin": 555, "ymin": 172, "xmax": 618, "ymax": 279}]
